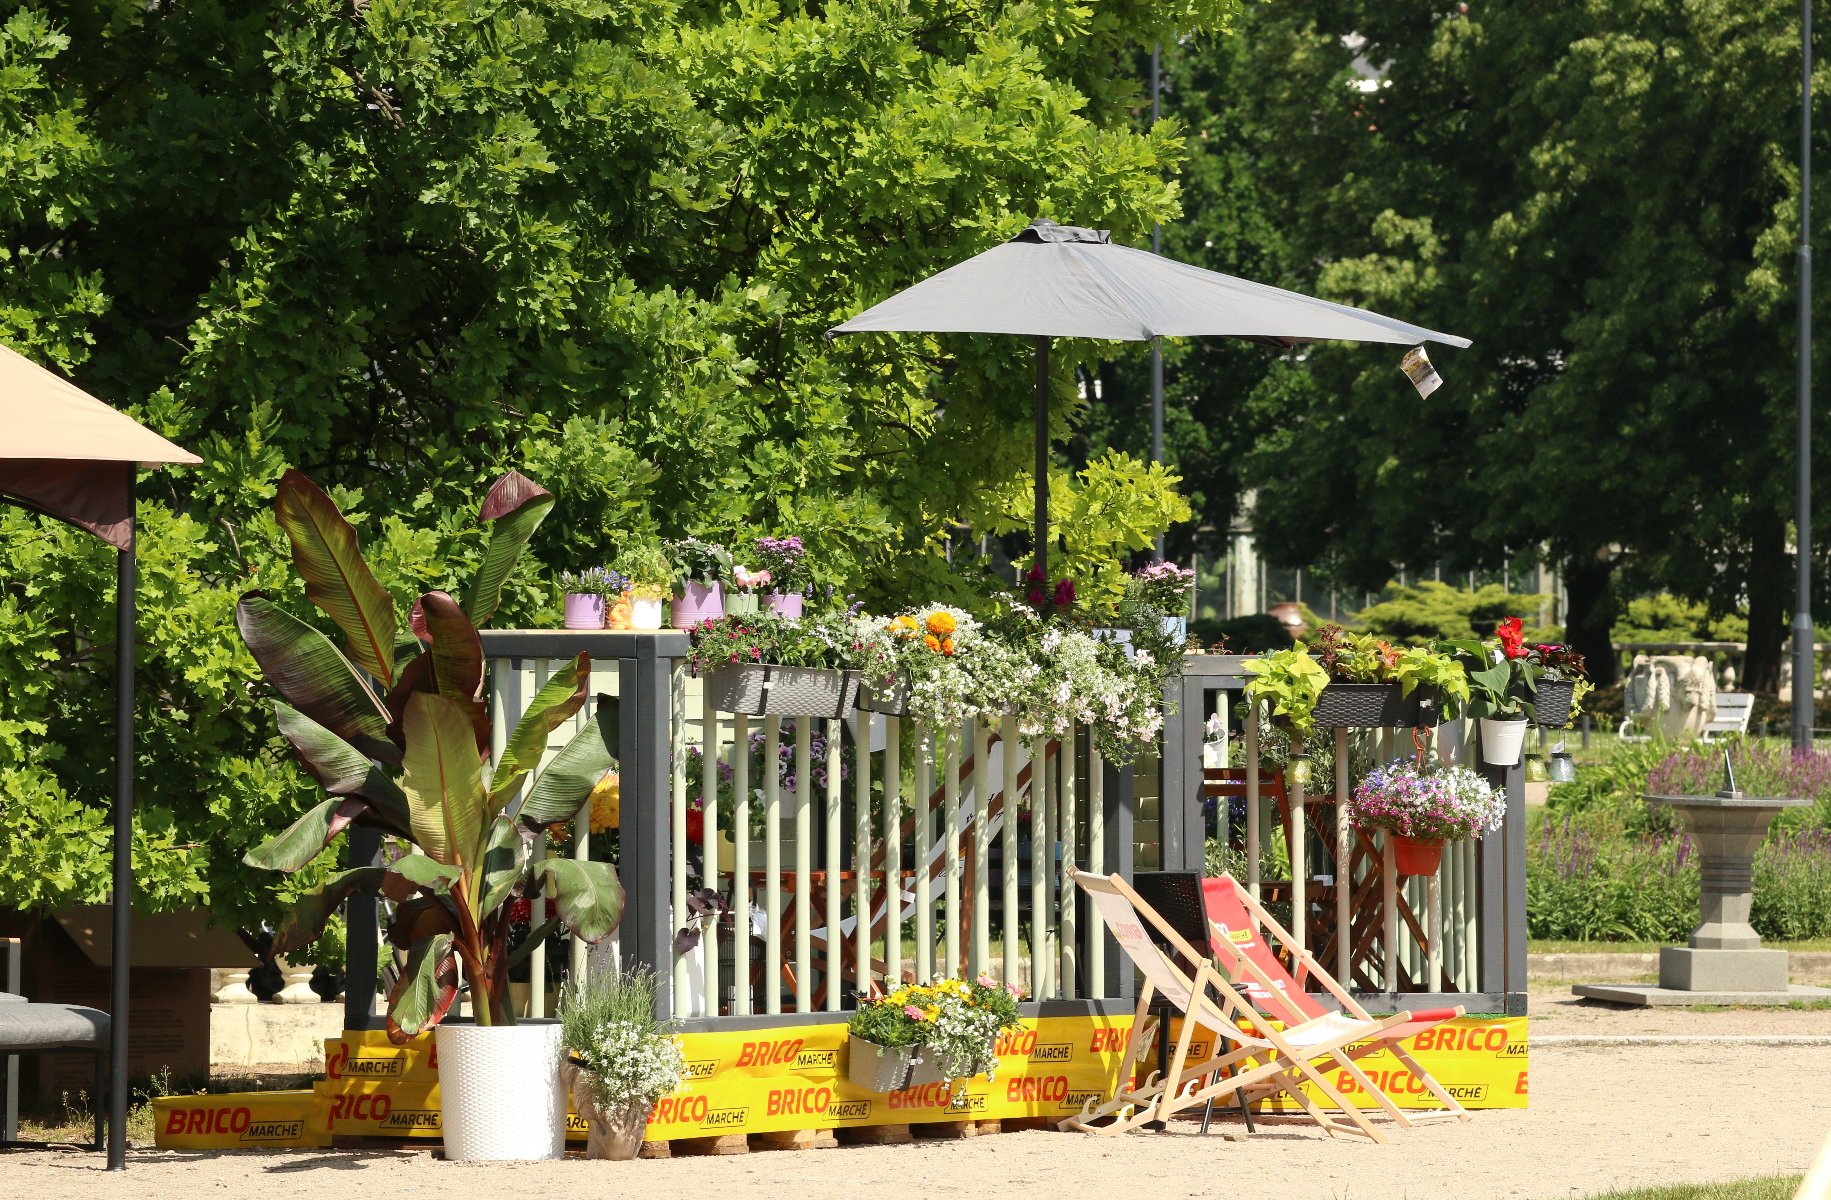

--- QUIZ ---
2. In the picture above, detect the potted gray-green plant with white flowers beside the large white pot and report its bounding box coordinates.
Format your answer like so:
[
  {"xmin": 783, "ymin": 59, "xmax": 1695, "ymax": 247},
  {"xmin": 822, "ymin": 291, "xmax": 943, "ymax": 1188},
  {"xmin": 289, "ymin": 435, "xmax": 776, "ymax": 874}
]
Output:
[{"xmin": 560, "ymin": 967, "xmax": 687, "ymax": 1160}]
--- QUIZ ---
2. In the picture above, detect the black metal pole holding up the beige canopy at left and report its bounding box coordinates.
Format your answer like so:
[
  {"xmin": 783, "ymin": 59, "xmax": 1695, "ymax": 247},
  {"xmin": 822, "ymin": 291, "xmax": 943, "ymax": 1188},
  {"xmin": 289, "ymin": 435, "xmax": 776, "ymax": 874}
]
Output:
[{"xmin": 108, "ymin": 476, "xmax": 137, "ymax": 1171}]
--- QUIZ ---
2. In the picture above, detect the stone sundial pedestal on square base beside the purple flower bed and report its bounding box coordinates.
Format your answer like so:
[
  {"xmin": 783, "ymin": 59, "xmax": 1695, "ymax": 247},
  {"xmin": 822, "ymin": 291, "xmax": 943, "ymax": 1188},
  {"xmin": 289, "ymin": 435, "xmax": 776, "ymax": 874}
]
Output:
[{"xmin": 1573, "ymin": 780, "xmax": 1831, "ymax": 1004}]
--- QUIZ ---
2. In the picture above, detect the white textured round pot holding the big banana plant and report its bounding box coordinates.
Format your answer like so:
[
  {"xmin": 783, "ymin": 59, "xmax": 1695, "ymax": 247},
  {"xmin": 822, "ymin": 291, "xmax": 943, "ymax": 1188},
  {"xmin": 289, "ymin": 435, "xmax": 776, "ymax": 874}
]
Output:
[{"xmin": 434, "ymin": 1020, "xmax": 566, "ymax": 1162}]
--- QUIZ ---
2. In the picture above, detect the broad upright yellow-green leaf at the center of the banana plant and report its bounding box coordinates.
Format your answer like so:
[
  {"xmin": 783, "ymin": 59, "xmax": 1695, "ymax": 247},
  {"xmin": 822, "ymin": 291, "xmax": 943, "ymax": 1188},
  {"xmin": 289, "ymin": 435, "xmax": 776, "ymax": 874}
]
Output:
[{"xmin": 401, "ymin": 693, "xmax": 483, "ymax": 870}]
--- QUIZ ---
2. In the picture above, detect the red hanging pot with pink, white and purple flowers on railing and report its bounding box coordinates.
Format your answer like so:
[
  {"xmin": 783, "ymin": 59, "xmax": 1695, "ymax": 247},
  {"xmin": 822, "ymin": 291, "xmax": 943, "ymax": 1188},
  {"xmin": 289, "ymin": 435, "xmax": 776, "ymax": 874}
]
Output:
[{"xmin": 1348, "ymin": 758, "xmax": 1507, "ymax": 876}]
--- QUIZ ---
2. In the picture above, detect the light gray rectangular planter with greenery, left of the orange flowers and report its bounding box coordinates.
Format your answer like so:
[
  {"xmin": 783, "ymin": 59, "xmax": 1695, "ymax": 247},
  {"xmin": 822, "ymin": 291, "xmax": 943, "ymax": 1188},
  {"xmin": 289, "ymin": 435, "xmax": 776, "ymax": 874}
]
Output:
[{"xmin": 687, "ymin": 612, "xmax": 859, "ymax": 716}]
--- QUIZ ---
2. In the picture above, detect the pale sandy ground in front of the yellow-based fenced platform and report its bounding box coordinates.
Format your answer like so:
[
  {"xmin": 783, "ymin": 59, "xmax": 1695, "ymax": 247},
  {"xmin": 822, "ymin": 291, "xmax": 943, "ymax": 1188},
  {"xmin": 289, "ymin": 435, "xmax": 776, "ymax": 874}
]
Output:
[{"xmin": 0, "ymin": 1040, "xmax": 1831, "ymax": 1200}]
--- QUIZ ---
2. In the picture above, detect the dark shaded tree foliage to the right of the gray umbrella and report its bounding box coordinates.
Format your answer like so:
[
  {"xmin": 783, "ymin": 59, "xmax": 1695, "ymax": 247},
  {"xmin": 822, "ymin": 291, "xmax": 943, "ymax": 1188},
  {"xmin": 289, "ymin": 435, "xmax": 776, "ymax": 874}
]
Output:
[{"xmin": 1133, "ymin": 0, "xmax": 1824, "ymax": 685}]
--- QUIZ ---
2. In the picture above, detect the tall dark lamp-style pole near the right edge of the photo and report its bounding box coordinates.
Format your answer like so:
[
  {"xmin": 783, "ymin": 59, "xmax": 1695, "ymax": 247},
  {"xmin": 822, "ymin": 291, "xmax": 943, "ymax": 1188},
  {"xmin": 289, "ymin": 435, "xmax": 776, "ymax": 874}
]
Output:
[{"xmin": 1793, "ymin": 0, "xmax": 1818, "ymax": 749}]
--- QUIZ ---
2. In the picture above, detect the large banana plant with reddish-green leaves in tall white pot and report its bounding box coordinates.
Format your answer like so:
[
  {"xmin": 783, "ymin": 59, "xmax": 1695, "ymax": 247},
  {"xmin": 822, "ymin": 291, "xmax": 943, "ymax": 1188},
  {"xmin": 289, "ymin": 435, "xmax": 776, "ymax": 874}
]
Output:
[{"xmin": 236, "ymin": 471, "xmax": 623, "ymax": 1160}]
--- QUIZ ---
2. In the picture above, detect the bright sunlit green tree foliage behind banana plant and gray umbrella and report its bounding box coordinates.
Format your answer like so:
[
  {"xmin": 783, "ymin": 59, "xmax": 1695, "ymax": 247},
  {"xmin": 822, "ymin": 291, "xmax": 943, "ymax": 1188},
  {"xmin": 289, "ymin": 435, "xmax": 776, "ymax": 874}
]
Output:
[{"xmin": 0, "ymin": 0, "xmax": 1236, "ymax": 920}]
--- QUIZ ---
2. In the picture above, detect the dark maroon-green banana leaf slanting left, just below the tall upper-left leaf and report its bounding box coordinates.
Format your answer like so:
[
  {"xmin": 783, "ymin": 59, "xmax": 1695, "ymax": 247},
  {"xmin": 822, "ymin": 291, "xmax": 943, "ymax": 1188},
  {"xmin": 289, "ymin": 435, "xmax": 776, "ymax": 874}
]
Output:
[{"xmin": 234, "ymin": 592, "xmax": 401, "ymax": 766}]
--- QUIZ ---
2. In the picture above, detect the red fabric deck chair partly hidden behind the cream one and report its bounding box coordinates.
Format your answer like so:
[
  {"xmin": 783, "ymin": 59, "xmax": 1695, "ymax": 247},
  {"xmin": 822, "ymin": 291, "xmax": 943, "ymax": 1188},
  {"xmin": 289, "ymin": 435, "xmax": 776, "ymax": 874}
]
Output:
[{"xmin": 1201, "ymin": 876, "xmax": 1470, "ymax": 1127}]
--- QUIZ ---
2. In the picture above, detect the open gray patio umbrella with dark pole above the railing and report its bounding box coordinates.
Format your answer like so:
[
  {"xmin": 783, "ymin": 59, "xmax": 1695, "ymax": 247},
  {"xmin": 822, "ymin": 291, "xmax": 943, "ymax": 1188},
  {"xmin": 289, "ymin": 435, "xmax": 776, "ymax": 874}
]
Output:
[{"xmin": 828, "ymin": 220, "xmax": 1468, "ymax": 577}]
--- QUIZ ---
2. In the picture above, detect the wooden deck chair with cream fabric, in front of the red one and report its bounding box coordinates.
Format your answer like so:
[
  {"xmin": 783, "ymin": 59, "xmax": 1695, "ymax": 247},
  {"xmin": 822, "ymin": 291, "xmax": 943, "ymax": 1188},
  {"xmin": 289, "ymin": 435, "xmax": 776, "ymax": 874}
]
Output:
[{"xmin": 1060, "ymin": 867, "xmax": 1386, "ymax": 1141}]
